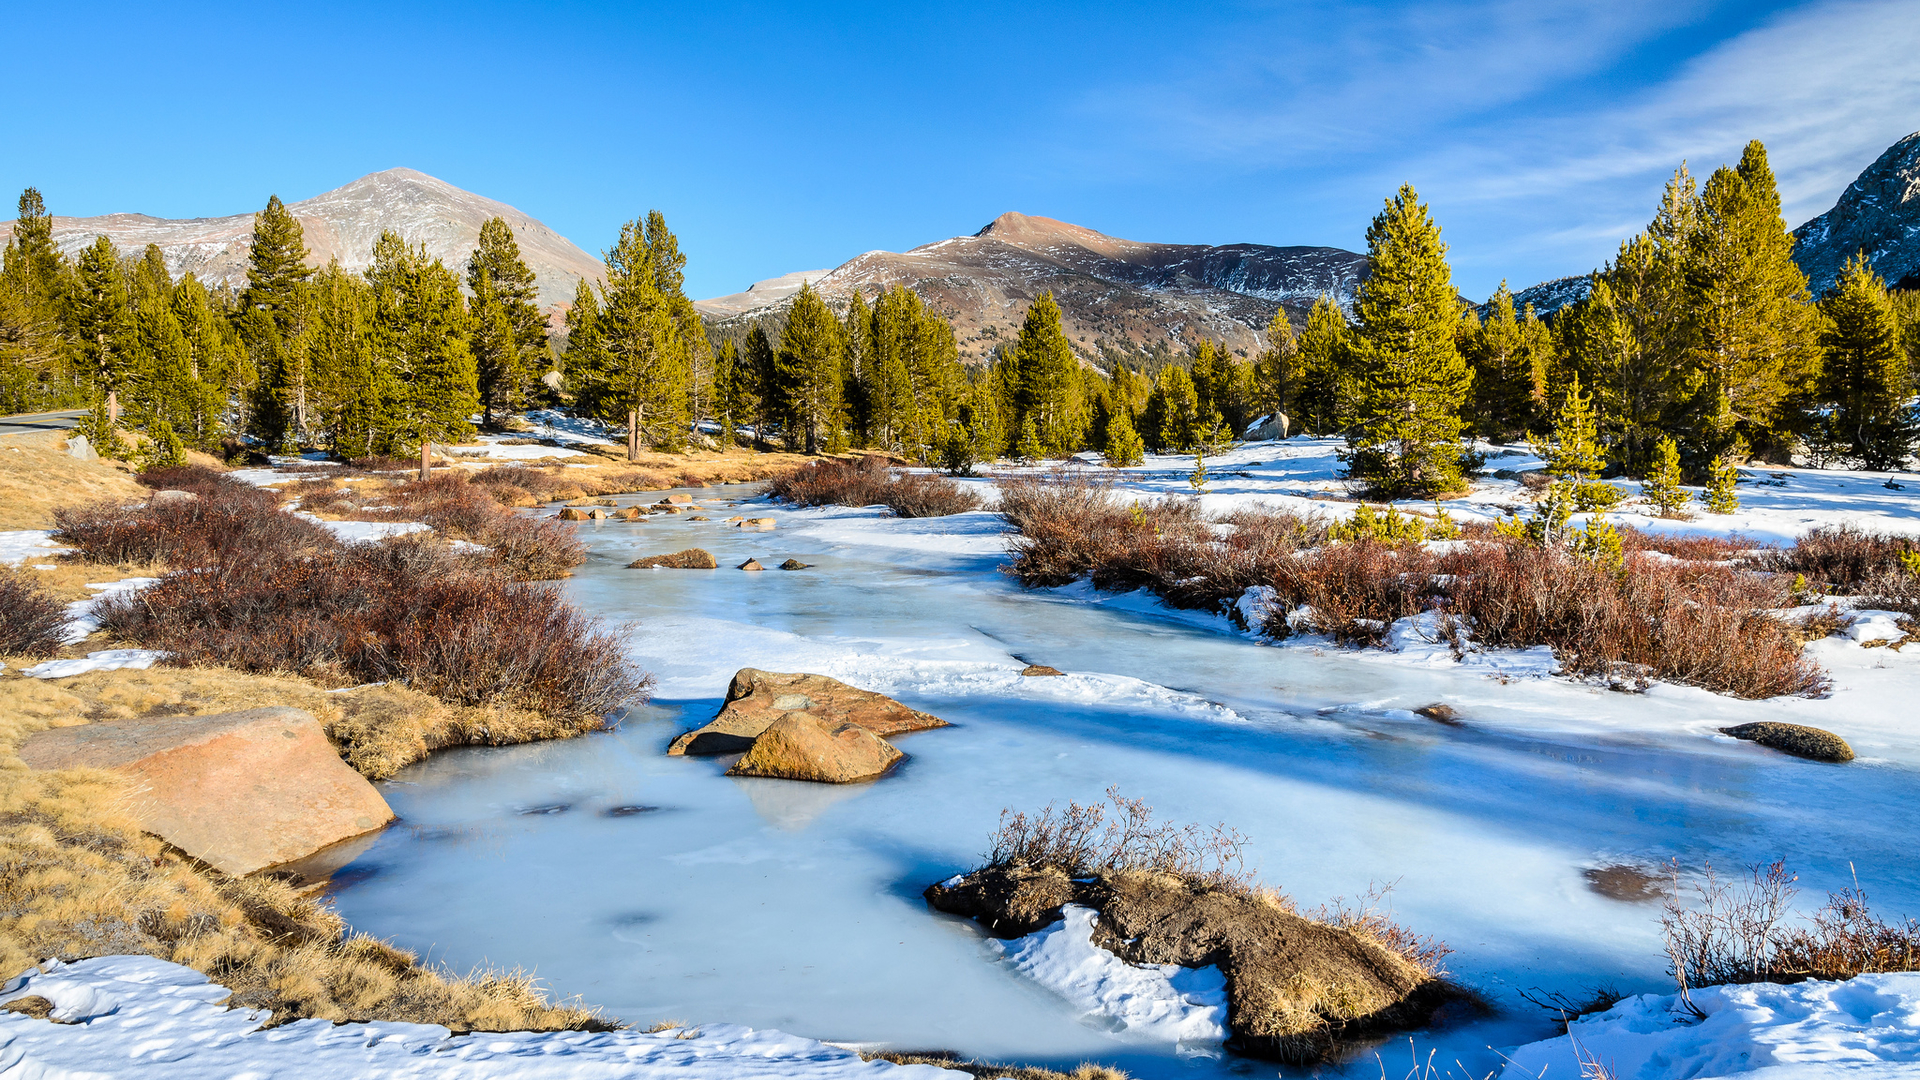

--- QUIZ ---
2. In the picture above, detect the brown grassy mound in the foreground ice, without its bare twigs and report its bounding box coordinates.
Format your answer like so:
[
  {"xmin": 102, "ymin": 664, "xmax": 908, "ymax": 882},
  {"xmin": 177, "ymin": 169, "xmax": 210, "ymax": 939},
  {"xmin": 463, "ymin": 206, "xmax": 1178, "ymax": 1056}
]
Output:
[{"xmin": 925, "ymin": 867, "xmax": 1461, "ymax": 1065}]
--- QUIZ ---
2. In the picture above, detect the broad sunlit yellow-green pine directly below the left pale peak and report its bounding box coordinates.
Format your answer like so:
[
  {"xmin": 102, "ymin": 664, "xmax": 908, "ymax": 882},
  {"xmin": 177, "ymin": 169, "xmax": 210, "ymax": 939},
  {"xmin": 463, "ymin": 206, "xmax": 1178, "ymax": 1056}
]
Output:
[{"xmin": 367, "ymin": 231, "xmax": 480, "ymax": 453}]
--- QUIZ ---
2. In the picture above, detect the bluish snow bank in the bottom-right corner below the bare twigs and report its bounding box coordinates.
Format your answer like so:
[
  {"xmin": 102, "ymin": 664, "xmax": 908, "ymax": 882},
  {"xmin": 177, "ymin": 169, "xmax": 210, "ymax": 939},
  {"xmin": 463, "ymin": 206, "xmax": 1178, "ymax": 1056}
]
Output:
[{"xmin": 1501, "ymin": 974, "xmax": 1920, "ymax": 1080}]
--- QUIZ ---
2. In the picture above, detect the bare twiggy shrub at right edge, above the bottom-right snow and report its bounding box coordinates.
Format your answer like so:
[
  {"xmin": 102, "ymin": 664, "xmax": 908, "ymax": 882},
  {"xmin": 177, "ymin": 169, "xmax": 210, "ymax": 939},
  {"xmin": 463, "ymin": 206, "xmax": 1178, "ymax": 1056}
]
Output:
[{"xmin": 1661, "ymin": 863, "xmax": 1920, "ymax": 997}]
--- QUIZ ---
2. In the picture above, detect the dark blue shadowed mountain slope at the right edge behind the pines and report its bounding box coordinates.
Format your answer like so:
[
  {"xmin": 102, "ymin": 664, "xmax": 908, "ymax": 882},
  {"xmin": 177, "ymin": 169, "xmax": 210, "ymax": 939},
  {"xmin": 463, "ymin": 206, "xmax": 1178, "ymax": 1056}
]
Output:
[{"xmin": 1793, "ymin": 131, "xmax": 1920, "ymax": 296}]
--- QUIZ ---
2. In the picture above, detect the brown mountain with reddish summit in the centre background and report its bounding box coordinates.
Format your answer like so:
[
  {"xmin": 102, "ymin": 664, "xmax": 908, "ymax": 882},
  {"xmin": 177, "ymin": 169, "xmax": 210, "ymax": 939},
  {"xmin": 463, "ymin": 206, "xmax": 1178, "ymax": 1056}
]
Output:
[{"xmin": 695, "ymin": 213, "xmax": 1367, "ymax": 359}]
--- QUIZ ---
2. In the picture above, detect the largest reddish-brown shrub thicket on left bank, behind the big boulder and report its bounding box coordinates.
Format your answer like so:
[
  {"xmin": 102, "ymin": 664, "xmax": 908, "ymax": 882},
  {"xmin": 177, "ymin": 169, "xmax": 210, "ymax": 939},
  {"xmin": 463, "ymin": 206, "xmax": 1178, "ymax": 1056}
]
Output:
[{"xmin": 100, "ymin": 536, "xmax": 651, "ymax": 721}]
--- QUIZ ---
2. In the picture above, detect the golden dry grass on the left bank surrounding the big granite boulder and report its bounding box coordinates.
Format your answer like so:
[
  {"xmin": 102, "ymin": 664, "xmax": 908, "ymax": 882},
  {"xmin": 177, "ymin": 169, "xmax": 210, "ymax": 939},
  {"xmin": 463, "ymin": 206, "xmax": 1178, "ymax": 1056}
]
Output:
[{"xmin": 0, "ymin": 669, "xmax": 609, "ymax": 1032}]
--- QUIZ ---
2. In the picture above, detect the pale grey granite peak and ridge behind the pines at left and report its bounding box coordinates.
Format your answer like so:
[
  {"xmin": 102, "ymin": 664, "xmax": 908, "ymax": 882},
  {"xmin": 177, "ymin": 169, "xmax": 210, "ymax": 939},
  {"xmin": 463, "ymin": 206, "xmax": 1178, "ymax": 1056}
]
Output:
[{"xmin": 11, "ymin": 169, "xmax": 603, "ymax": 307}]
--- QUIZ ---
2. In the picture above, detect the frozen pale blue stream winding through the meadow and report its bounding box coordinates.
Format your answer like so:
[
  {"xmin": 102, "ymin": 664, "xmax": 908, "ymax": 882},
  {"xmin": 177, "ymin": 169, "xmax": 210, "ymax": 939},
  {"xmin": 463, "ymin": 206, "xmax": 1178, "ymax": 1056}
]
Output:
[{"xmin": 336, "ymin": 488, "xmax": 1920, "ymax": 1078}]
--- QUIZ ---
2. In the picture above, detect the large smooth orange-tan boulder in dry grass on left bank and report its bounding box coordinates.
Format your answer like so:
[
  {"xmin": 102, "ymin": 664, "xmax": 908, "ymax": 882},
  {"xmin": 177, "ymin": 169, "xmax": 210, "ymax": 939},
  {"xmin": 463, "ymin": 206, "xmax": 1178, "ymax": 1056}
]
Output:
[{"xmin": 19, "ymin": 707, "xmax": 394, "ymax": 874}]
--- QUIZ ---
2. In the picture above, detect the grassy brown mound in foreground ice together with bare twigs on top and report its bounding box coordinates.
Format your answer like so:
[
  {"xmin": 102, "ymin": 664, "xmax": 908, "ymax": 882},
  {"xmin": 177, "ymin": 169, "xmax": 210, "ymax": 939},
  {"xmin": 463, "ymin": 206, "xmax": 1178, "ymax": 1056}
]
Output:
[{"xmin": 925, "ymin": 790, "xmax": 1467, "ymax": 1063}]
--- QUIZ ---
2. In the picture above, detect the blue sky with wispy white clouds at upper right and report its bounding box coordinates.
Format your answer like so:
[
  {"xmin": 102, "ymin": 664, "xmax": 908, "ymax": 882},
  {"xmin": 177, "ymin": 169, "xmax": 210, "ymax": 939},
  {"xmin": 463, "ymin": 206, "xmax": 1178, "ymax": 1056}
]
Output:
[{"xmin": 0, "ymin": 0, "xmax": 1920, "ymax": 298}]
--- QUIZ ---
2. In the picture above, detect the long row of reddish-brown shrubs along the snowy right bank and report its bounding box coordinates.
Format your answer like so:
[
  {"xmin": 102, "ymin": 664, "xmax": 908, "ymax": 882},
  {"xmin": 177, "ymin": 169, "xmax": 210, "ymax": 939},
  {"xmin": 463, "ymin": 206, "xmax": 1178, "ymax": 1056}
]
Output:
[{"xmin": 1000, "ymin": 475, "xmax": 1828, "ymax": 698}]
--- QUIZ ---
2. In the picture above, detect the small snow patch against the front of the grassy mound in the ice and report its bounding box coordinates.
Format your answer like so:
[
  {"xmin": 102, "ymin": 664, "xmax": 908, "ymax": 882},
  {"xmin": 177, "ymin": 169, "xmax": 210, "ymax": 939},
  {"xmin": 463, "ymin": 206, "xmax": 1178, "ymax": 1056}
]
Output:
[{"xmin": 991, "ymin": 903, "xmax": 1227, "ymax": 1042}]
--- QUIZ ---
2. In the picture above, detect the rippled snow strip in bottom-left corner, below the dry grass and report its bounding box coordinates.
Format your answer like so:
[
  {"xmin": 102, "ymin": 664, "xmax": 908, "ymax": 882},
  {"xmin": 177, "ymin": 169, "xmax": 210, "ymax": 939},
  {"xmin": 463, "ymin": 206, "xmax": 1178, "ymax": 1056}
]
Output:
[{"xmin": 0, "ymin": 957, "xmax": 954, "ymax": 1080}]
